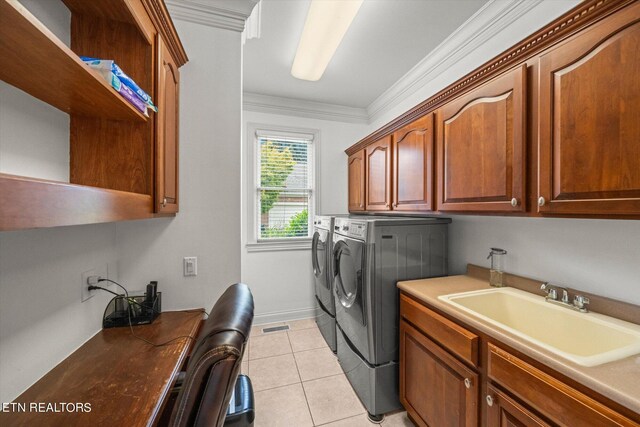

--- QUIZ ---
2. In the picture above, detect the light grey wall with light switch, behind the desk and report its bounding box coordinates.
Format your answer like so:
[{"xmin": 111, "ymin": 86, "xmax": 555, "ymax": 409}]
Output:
[{"xmin": 116, "ymin": 21, "xmax": 242, "ymax": 310}]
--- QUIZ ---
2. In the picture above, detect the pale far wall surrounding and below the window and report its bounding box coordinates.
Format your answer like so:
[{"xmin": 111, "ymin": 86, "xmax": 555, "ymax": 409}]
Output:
[{"xmin": 242, "ymin": 111, "xmax": 367, "ymax": 323}]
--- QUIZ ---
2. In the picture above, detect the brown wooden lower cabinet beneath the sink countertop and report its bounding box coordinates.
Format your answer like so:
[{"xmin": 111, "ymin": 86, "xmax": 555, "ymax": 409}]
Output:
[{"xmin": 400, "ymin": 293, "xmax": 640, "ymax": 427}]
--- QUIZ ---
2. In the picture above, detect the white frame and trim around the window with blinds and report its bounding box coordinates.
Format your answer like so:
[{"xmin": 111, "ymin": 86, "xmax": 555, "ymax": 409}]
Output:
[{"xmin": 245, "ymin": 123, "xmax": 320, "ymax": 252}]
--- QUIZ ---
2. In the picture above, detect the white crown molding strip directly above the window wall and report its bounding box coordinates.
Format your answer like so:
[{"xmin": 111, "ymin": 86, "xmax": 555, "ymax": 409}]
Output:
[{"xmin": 242, "ymin": 92, "xmax": 369, "ymax": 124}]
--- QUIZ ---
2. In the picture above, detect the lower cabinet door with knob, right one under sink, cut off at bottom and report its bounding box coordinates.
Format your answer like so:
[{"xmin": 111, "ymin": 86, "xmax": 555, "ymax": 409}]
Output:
[{"xmin": 485, "ymin": 385, "xmax": 551, "ymax": 427}]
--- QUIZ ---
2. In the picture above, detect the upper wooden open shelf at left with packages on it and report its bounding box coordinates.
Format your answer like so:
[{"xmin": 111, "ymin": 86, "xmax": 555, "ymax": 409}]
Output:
[{"xmin": 0, "ymin": 0, "xmax": 147, "ymax": 122}]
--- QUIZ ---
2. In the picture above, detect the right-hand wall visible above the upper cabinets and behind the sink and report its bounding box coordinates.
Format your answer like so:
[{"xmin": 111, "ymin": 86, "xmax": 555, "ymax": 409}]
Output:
[{"xmin": 360, "ymin": 0, "xmax": 640, "ymax": 304}]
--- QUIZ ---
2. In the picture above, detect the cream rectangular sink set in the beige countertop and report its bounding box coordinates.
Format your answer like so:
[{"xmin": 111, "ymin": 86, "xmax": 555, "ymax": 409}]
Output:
[{"xmin": 438, "ymin": 288, "xmax": 640, "ymax": 366}]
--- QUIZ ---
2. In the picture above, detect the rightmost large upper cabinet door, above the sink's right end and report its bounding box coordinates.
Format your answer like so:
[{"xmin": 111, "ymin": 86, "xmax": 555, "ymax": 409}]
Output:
[{"xmin": 538, "ymin": 3, "xmax": 640, "ymax": 215}]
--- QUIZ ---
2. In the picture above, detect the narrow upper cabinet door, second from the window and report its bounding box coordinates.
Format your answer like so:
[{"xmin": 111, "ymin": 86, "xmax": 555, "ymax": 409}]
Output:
[{"xmin": 364, "ymin": 135, "xmax": 391, "ymax": 211}]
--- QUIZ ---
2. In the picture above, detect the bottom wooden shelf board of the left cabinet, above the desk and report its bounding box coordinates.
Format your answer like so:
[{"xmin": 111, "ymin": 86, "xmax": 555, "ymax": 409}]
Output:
[{"xmin": 0, "ymin": 173, "xmax": 156, "ymax": 231}]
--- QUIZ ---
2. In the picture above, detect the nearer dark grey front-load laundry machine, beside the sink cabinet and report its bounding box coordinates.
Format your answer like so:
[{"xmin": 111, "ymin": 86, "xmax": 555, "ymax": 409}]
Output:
[{"xmin": 331, "ymin": 217, "xmax": 451, "ymax": 420}]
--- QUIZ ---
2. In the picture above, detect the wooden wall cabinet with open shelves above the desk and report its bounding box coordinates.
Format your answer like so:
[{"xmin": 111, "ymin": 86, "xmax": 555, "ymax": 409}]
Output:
[{"xmin": 0, "ymin": 0, "xmax": 187, "ymax": 231}]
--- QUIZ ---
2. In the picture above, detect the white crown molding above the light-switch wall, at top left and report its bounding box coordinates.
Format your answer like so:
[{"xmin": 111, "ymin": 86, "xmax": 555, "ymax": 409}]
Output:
[{"xmin": 165, "ymin": 0, "xmax": 259, "ymax": 32}]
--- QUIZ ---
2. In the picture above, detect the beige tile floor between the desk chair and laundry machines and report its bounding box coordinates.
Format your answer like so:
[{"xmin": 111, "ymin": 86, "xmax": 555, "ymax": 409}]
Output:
[{"xmin": 242, "ymin": 319, "xmax": 413, "ymax": 427}]
